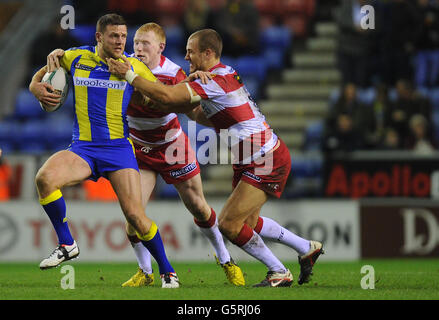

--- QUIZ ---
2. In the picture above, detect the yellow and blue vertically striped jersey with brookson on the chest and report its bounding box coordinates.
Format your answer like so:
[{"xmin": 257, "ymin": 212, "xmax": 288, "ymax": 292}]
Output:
[{"xmin": 60, "ymin": 46, "xmax": 157, "ymax": 142}]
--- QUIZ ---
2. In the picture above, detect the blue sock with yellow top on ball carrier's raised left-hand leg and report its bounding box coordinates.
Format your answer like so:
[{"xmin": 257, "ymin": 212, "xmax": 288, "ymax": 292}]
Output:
[{"xmin": 40, "ymin": 190, "xmax": 74, "ymax": 245}]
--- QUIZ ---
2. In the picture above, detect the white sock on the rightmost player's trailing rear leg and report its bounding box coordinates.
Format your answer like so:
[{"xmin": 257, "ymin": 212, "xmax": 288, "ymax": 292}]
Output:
[{"xmin": 259, "ymin": 217, "xmax": 310, "ymax": 255}]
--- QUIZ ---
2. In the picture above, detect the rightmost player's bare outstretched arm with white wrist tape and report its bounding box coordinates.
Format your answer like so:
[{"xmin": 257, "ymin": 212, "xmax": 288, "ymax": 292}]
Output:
[{"xmin": 108, "ymin": 57, "xmax": 201, "ymax": 108}]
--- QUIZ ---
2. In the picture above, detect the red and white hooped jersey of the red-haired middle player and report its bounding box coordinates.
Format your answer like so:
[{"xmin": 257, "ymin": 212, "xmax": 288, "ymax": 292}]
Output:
[{"xmin": 127, "ymin": 55, "xmax": 186, "ymax": 145}]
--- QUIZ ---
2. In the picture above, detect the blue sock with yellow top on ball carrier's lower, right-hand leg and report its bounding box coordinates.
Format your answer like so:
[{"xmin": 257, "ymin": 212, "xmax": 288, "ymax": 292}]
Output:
[{"xmin": 137, "ymin": 222, "xmax": 175, "ymax": 274}]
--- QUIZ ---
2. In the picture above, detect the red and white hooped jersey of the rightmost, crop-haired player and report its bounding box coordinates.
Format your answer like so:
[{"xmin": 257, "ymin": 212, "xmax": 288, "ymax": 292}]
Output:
[{"xmin": 189, "ymin": 63, "xmax": 278, "ymax": 163}]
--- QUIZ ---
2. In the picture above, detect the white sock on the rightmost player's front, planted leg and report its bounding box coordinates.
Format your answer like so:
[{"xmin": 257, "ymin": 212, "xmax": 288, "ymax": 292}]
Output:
[{"xmin": 240, "ymin": 231, "xmax": 287, "ymax": 272}]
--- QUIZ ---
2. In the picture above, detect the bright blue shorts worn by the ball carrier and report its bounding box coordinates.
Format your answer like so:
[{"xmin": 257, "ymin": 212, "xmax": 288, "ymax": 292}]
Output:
[{"xmin": 67, "ymin": 139, "xmax": 139, "ymax": 181}]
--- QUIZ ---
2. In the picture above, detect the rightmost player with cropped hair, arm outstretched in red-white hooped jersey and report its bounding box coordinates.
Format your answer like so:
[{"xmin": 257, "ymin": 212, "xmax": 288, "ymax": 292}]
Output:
[{"xmin": 108, "ymin": 29, "xmax": 323, "ymax": 287}]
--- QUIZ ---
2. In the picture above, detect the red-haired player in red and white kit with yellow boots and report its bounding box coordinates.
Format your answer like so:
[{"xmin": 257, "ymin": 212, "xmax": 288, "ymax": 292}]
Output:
[{"xmin": 122, "ymin": 23, "xmax": 245, "ymax": 287}]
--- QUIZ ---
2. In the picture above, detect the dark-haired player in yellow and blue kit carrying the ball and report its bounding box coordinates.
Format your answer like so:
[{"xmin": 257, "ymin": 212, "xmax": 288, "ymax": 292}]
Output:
[{"xmin": 29, "ymin": 14, "xmax": 179, "ymax": 288}]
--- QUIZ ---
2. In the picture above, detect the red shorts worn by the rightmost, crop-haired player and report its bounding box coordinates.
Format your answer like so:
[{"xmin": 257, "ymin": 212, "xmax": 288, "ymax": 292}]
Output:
[{"xmin": 233, "ymin": 138, "xmax": 291, "ymax": 198}]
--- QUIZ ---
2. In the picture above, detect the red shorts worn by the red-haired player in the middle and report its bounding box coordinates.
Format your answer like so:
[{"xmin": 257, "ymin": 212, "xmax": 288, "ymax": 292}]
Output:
[{"xmin": 134, "ymin": 132, "xmax": 200, "ymax": 184}]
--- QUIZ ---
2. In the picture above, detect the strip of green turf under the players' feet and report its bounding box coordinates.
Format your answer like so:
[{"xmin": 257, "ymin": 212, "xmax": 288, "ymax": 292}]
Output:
[{"xmin": 0, "ymin": 259, "xmax": 439, "ymax": 300}]
